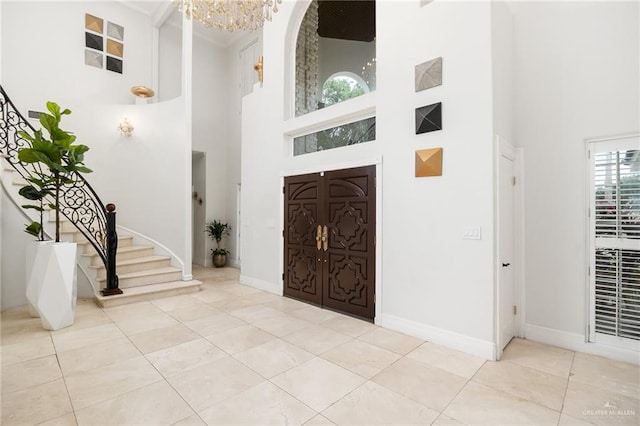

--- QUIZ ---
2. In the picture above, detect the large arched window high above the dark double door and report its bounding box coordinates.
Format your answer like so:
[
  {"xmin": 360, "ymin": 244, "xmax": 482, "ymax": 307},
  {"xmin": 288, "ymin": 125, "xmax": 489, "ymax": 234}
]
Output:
[{"xmin": 295, "ymin": 0, "xmax": 376, "ymax": 116}]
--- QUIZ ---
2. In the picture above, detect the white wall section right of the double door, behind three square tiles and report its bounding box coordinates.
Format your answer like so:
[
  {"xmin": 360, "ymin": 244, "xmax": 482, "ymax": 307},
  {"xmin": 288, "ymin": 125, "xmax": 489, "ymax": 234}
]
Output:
[{"xmin": 376, "ymin": 2, "xmax": 494, "ymax": 358}]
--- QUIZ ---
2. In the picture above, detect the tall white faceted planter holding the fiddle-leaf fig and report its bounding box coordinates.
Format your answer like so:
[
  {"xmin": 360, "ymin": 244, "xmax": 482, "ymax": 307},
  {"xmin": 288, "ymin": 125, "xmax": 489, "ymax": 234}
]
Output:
[{"xmin": 27, "ymin": 241, "xmax": 78, "ymax": 330}]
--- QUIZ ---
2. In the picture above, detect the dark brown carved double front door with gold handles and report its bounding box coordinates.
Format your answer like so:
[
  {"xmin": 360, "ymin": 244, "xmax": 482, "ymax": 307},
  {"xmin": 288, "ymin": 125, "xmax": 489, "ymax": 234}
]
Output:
[{"xmin": 284, "ymin": 166, "xmax": 376, "ymax": 320}]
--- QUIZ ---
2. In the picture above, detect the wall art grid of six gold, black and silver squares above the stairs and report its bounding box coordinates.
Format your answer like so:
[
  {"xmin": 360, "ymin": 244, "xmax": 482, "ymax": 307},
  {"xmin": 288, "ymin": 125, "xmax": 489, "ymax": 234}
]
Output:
[{"xmin": 84, "ymin": 13, "xmax": 124, "ymax": 74}]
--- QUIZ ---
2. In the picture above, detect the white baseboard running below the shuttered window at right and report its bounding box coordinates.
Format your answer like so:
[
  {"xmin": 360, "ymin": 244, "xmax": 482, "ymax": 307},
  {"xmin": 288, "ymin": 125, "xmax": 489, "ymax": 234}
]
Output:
[{"xmin": 524, "ymin": 324, "xmax": 640, "ymax": 365}]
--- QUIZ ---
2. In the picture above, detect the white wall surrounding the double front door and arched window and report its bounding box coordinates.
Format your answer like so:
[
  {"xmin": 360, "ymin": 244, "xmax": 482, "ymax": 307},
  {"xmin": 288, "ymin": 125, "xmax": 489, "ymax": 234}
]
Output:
[{"xmin": 242, "ymin": 1, "xmax": 494, "ymax": 358}]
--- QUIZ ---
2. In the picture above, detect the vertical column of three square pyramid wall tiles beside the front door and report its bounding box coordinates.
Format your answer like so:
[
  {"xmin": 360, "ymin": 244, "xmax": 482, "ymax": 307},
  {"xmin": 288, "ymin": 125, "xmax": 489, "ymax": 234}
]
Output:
[{"xmin": 415, "ymin": 58, "xmax": 442, "ymax": 177}]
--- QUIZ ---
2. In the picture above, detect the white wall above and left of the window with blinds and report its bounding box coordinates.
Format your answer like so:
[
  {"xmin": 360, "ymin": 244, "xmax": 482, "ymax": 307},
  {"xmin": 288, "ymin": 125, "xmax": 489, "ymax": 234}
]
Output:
[{"xmin": 510, "ymin": 1, "xmax": 640, "ymax": 350}]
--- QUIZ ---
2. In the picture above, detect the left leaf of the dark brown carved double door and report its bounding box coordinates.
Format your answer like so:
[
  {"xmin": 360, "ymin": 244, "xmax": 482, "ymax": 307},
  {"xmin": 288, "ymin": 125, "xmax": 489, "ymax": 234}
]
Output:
[{"xmin": 283, "ymin": 174, "xmax": 324, "ymax": 305}]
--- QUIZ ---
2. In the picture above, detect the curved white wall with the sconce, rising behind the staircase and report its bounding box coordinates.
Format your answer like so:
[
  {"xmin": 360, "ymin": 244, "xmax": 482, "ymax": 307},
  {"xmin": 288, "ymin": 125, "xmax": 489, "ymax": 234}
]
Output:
[{"xmin": 65, "ymin": 98, "xmax": 191, "ymax": 261}]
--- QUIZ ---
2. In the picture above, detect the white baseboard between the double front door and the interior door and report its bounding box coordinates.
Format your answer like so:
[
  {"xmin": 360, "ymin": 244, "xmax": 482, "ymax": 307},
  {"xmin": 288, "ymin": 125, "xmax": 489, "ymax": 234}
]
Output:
[{"xmin": 375, "ymin": 314, "xmax": 496, "ymax": 361}]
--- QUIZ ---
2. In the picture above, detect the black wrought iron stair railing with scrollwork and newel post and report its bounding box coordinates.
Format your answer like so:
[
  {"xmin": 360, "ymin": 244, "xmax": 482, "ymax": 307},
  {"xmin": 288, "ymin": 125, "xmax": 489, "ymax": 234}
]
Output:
[{"xmin": 0, "ymin": 86, "xmax": 122, "ymax": 296}]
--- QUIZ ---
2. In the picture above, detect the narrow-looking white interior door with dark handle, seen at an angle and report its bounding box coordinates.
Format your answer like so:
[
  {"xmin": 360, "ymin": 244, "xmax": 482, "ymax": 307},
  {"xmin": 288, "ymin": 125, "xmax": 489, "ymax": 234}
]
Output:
[{"xmin": 498, "ymin": 151, "xmax": 516, "ymax": 352}]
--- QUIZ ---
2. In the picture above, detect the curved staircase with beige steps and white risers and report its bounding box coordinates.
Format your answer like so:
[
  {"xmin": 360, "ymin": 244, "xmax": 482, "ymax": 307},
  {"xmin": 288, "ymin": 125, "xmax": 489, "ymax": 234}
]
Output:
[{"xmin": 0, "ymin": 87, "xmax": 202, "ymax": 307}]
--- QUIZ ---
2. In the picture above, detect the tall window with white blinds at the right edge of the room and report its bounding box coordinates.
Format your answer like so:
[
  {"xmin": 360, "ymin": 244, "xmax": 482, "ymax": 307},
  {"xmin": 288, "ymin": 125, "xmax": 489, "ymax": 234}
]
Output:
[{"xmin": 589, "ymin": 137, "xmax": 640, "ymax": 346}]
